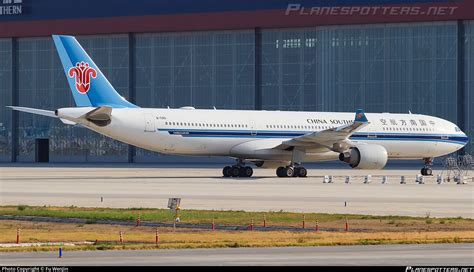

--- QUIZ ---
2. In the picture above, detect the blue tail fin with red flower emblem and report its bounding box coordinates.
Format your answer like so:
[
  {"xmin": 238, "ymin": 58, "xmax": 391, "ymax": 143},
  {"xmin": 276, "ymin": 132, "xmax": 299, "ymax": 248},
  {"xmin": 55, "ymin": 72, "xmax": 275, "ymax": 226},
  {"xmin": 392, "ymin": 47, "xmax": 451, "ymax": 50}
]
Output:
[{"xmin": 53, "ymin": 35, "xmax": 137, "ymax": 108}]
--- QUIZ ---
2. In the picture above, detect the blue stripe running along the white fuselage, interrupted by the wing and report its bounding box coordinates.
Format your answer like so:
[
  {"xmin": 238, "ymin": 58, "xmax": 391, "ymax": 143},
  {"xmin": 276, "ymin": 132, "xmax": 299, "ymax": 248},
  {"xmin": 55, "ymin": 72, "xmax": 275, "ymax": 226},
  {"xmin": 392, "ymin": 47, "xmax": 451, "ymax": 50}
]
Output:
[{"xmin": 158, "ymin": 128, "xmax": 468, "ymax": 145}]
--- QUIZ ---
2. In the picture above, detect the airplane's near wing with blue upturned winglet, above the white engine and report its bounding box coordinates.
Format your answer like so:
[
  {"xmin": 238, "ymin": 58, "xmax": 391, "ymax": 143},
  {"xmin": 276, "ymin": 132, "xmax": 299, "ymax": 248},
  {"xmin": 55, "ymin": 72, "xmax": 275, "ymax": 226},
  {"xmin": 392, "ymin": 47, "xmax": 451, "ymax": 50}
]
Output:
[{"xmin": 275, "ymin": 109, "xmax": 369, "ymax": 152}]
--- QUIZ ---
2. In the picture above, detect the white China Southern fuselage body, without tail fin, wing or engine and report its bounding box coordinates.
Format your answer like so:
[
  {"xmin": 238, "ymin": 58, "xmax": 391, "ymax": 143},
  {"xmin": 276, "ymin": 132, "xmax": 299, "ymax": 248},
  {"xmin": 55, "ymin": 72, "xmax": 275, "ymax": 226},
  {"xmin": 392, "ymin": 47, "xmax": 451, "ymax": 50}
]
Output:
[{"xmin": 60, "ymin": 108, "xmax": 467, "ymax": 164}]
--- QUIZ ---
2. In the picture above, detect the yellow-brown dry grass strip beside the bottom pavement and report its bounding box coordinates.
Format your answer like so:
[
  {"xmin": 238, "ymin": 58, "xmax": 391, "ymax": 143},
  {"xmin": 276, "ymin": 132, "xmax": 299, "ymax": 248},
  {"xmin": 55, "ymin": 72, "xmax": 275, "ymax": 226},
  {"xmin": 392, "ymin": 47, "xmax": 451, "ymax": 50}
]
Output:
[{"xmin": 0, "ymin": 221, "xmax": 474, "ymax": 251}]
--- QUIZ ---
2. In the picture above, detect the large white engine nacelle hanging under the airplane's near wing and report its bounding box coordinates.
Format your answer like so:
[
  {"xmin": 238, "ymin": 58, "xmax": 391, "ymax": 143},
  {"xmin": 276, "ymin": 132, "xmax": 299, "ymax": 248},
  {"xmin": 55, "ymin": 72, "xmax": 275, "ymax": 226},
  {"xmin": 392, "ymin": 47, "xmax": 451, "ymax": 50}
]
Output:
[{"xmin": 339, "ymin": 144, "xmax": 388, "ymax": 169}]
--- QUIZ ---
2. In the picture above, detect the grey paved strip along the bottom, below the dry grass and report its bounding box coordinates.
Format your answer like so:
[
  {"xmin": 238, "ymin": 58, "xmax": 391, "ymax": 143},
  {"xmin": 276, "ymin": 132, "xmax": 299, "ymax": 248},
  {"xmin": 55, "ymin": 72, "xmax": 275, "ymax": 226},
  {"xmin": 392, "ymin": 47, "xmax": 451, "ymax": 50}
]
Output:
[{"xmin": 0, "ymin": 244, "xmax": 474, "ymax": 266}]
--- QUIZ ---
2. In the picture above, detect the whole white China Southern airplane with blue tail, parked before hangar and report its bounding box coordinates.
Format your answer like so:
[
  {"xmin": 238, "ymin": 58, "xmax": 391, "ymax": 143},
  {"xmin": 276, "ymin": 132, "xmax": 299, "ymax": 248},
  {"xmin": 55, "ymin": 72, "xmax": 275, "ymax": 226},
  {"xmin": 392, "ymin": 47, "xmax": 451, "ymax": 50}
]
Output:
[{"xmin": 9, "ymin": 35, "xmax": 468, "ymax": 177}]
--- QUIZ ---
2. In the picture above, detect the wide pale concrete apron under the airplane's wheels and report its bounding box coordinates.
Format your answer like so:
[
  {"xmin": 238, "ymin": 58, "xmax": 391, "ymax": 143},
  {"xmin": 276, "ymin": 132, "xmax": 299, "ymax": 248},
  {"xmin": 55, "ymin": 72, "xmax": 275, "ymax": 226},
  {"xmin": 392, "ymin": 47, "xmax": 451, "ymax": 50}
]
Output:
[{"xmin": 0, "ymin": 164, "xmax": 474, "ymax": 218}]
